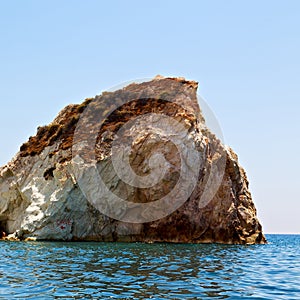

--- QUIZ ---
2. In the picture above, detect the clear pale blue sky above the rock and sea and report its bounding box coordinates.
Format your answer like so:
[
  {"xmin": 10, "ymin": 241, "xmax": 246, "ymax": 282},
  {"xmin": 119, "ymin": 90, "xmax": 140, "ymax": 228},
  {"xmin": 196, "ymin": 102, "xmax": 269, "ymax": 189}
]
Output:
[{"xmin": 0, "ymin": 0, "xmax": 300, "ymax": 233}]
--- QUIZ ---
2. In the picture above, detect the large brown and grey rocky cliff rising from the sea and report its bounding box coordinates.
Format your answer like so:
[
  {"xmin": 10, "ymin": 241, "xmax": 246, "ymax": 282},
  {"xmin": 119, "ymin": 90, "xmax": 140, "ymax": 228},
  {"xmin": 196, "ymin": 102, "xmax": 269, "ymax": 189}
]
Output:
[{"xmin": 0, "ymin": 77, "xmax": 265, "ymax": 244}]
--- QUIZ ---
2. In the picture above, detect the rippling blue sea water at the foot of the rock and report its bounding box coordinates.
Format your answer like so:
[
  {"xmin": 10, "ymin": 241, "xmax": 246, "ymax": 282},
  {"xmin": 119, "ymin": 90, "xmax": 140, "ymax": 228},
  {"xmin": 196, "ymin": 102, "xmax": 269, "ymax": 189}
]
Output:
[{"xmin": 0, "ymin": 235, "xmax": 300, "ymax": 300}]
